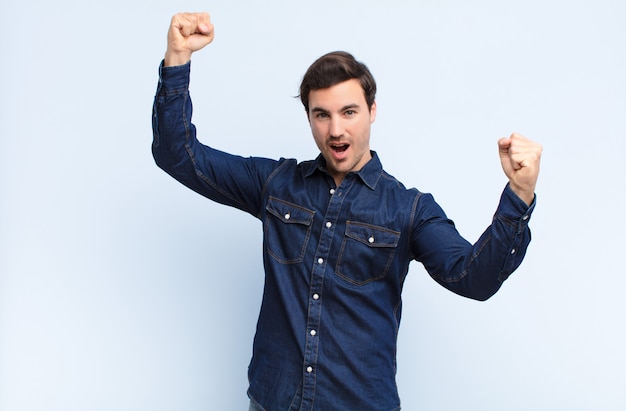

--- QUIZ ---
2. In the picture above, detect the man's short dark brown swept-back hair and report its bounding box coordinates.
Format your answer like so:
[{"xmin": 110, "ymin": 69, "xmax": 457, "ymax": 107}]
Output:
[{"xmin": 299, "ymin": 51, "xmax": 376, "ymax": 113}]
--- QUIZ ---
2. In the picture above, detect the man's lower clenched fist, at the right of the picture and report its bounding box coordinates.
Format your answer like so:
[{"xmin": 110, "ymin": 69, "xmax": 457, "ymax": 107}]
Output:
[{"xmin": 498, "ymin": 133, "xmax": 542, "ymax": 205}]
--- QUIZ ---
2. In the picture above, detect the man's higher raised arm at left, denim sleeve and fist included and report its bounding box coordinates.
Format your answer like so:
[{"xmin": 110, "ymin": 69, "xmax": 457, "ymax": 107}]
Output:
[{"xmin": 152, "ymin": 13, "xmax": 279, "ymax": 216}]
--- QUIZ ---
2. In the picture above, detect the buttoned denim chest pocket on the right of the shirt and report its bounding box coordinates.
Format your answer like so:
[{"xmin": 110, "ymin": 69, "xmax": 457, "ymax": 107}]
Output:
[{"xmin": 336, "ymin": 221, "xmax": 400, "ymax": 285}]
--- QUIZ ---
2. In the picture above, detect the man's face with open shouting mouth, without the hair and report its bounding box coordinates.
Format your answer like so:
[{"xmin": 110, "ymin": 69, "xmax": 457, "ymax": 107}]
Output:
[{"xmin": 308, "ymin": 79, "xmax": 376, "ymax": 185}]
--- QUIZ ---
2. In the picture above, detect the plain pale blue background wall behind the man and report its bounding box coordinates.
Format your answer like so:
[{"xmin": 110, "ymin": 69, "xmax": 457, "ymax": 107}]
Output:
[{"xmin": 0, "ymin": 0, "xmax": 626, "ymax": 411}]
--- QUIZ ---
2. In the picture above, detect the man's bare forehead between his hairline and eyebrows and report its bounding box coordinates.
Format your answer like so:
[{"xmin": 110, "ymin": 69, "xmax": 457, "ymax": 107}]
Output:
[{"xmin": 309, "ymin": 79, "xmax": 367, "ymax": 111}]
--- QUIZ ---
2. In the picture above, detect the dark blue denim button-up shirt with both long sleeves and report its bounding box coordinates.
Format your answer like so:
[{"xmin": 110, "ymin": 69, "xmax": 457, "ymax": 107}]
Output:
[{"xmin": 152, "ymin": 63, "xmax": 534, "ymax": 411}]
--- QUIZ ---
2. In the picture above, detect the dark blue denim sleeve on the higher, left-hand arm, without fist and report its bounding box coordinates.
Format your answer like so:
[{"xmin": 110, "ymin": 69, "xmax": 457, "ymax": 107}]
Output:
[{"xmin": 152, "ymin": 62, "xmax": 280, "ymax": 217}]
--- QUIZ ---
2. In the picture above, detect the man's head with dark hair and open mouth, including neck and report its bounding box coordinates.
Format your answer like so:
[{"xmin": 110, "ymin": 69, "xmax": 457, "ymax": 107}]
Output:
[{"xmin": 300, "ymin": 52, "xmax": 376, "ymax": 185}]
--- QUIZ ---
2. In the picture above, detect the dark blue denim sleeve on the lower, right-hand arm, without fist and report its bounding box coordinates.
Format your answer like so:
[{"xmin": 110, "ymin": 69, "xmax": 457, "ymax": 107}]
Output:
[{"xmin": 413, "ymin": 185, "xmax": 536, "ymax": 301}]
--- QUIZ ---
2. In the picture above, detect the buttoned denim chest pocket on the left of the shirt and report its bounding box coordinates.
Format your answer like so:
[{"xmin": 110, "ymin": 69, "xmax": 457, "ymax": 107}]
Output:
[{"xmin": 264, "ymin": 197, "xmax": 315, "ymax": 264}]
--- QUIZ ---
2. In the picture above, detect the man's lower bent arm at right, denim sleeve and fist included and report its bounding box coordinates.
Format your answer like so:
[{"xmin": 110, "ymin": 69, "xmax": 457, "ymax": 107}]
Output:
[{"xmin": 413, "ymin": 133, "xmax": 542, "ymax": 300}]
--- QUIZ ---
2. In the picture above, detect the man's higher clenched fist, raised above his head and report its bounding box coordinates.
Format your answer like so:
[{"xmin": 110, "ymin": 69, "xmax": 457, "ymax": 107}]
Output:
[{"xmin": 164, "ymin": 13, "xmax": 215, "ymax": 66}]
